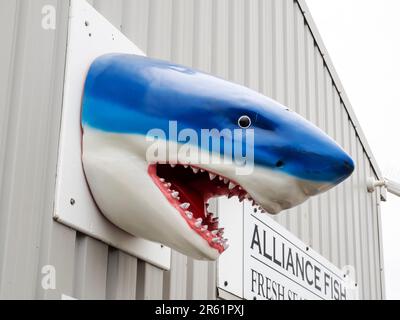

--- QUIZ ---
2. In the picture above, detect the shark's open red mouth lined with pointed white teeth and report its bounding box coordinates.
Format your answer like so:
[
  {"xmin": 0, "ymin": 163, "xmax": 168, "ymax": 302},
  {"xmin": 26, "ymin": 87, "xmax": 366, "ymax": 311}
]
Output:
[{"xmin": 149, "ymin": 164, "xmax": 256, "ymax": 253}]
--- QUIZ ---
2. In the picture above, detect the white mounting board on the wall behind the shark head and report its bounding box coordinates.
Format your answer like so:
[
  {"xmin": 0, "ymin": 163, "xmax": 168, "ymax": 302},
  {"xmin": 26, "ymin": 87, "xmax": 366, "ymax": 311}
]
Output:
[{"xmin": 54, "ymin": 0, "xmax": 171, "ymax": 269}]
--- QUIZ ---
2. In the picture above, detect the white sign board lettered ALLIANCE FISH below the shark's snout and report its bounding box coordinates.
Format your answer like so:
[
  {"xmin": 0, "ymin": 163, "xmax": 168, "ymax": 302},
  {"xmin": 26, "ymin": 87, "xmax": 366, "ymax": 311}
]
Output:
[{"xmin": 218, "ymin": 200, "xmax": 357, "ymax": 300}]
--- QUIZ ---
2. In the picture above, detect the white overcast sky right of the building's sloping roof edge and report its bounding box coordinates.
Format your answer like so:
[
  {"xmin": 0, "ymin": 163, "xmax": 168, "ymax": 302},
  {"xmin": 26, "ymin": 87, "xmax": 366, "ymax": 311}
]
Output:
[{"xmin": 307, "ymin": 0, "xmax": 400, "ymax": 299}]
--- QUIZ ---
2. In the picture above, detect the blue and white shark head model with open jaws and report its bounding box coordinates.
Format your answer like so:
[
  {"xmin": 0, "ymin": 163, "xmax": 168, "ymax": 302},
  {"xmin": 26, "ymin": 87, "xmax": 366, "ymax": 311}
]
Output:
[{"xmin": 82, "ymin": 54, "xmax": 354, "ymax": 260}]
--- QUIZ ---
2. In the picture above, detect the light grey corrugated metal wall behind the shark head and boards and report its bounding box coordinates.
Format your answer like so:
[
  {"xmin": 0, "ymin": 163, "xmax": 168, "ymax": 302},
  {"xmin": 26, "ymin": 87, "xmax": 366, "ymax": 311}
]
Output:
[{"xmin": 0, "ymin": 0, "xmax": 383, "ymax": 299}]
